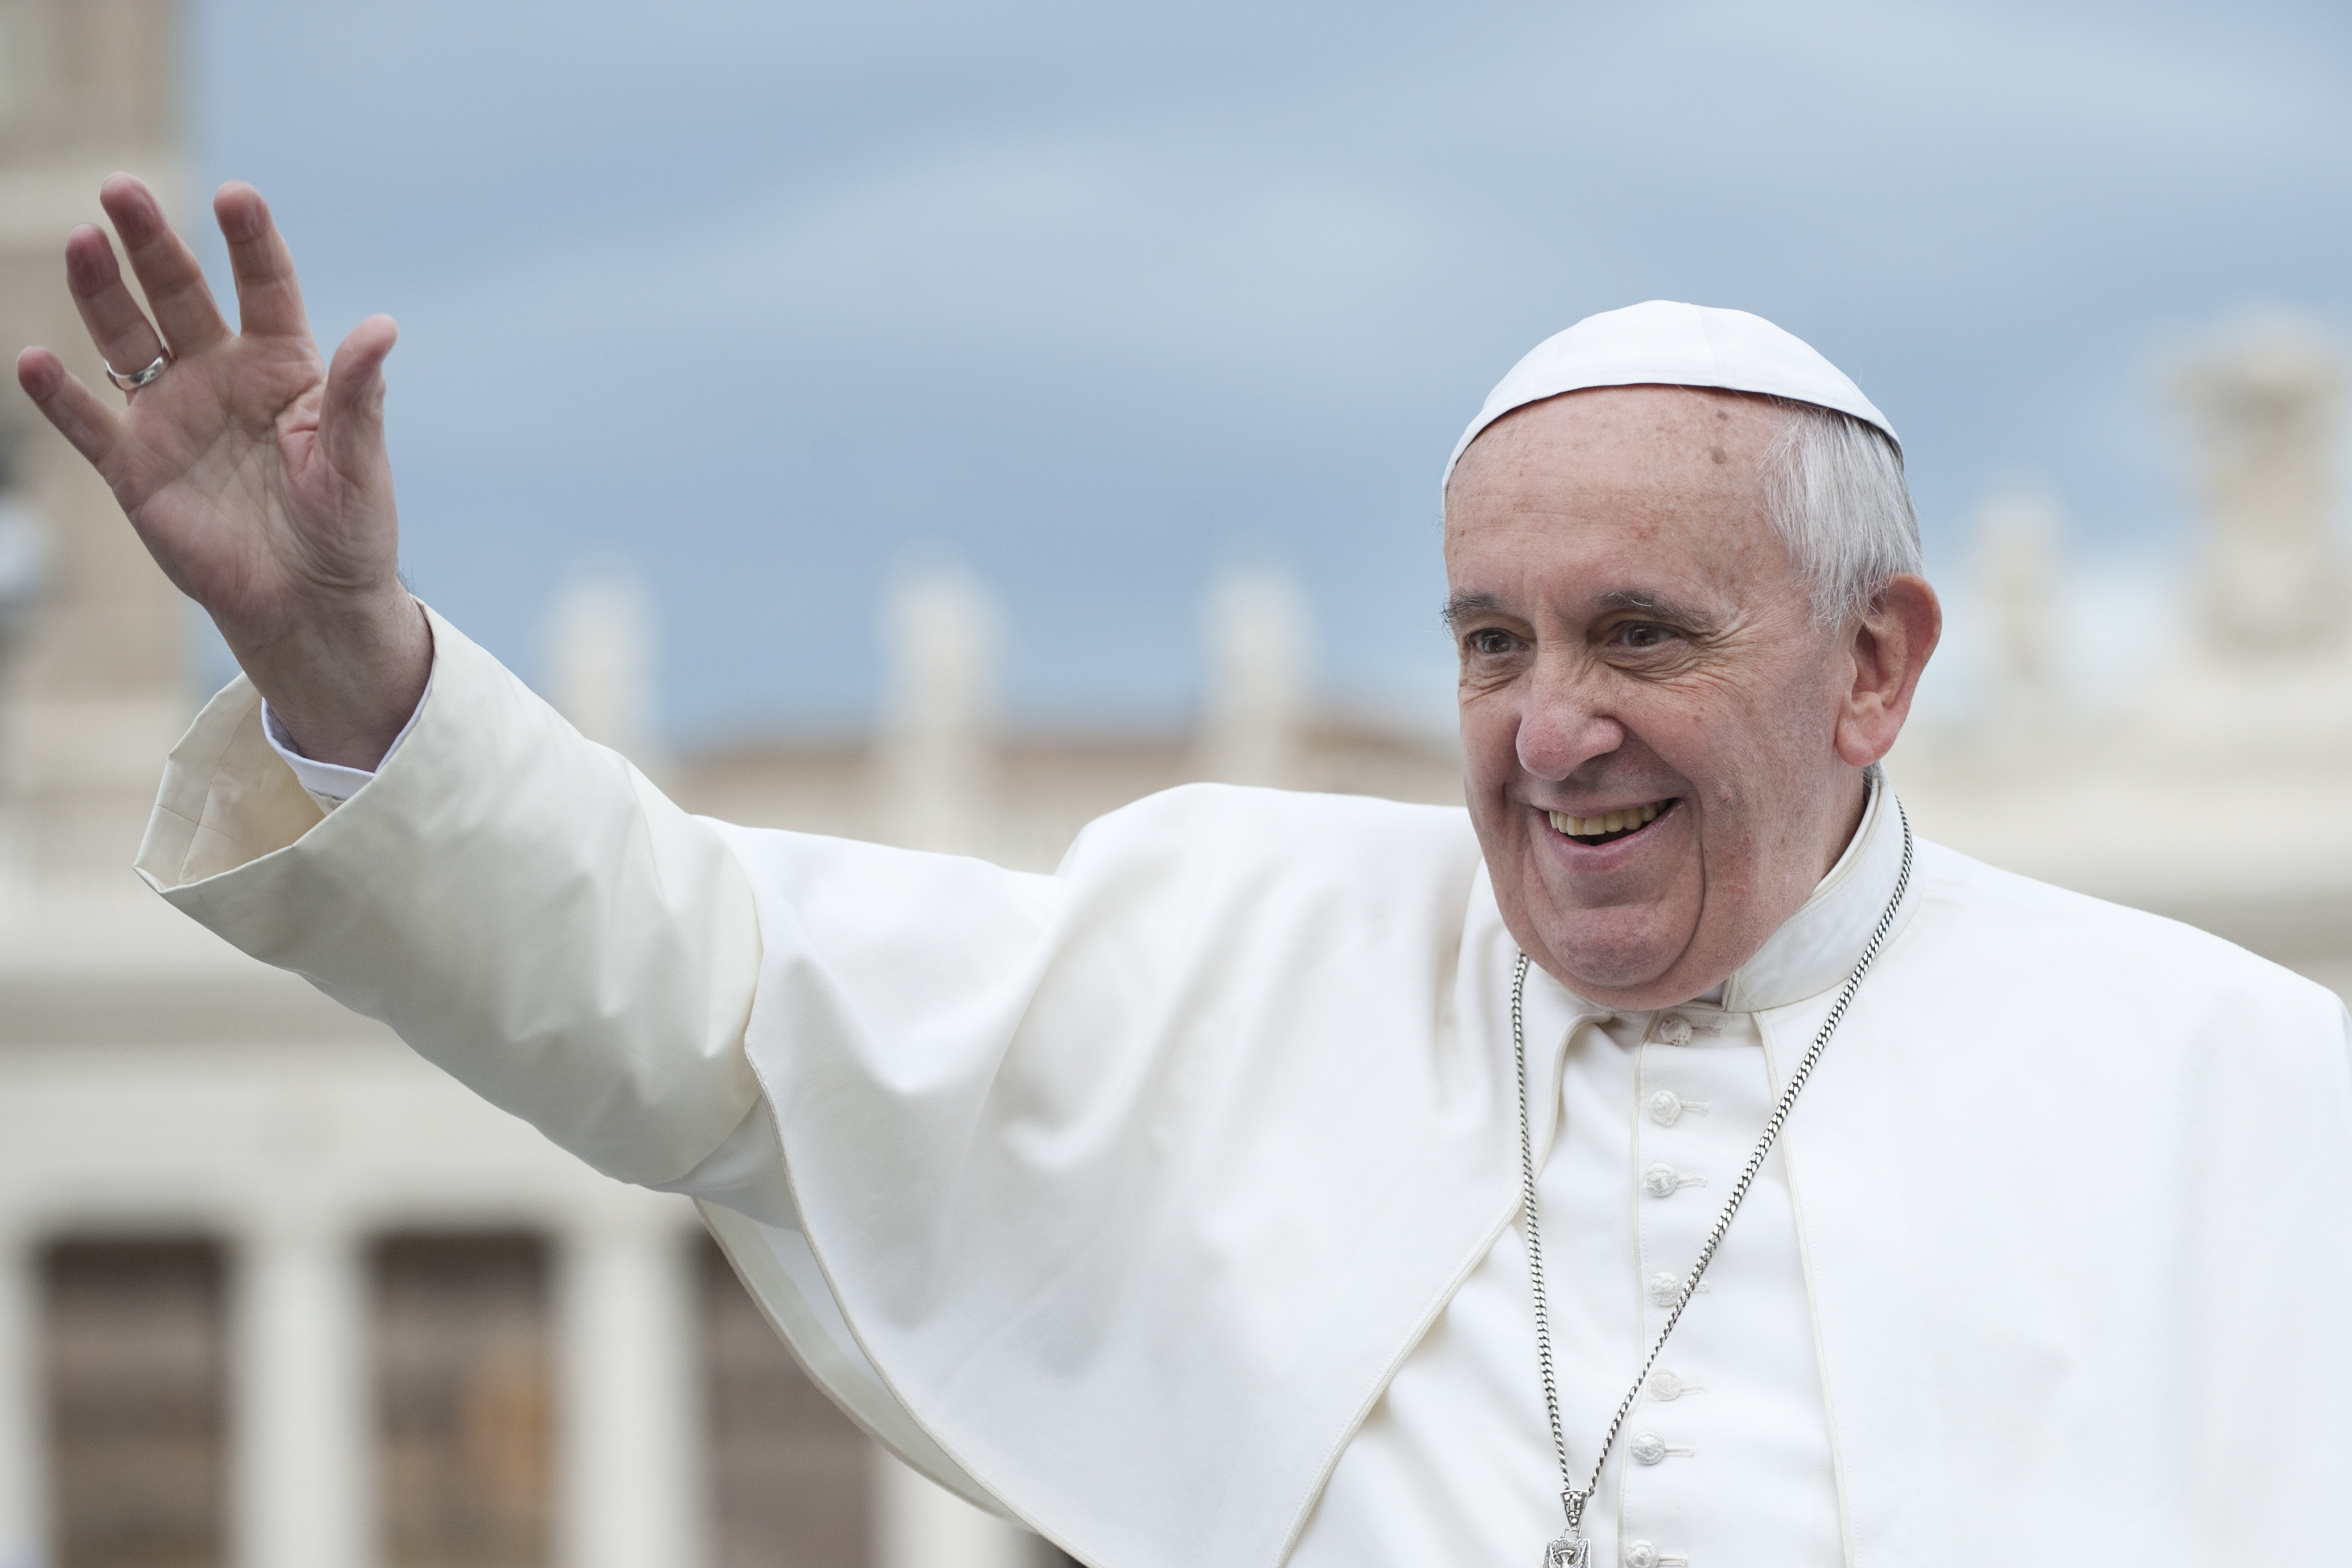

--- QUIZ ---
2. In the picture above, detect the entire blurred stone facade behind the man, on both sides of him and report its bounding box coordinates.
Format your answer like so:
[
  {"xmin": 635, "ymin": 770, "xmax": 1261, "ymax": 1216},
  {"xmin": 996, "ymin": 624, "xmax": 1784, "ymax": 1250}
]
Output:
[{"xmin": 0, "ymin": 0, "xmax": 2352, "ymax": 1568}]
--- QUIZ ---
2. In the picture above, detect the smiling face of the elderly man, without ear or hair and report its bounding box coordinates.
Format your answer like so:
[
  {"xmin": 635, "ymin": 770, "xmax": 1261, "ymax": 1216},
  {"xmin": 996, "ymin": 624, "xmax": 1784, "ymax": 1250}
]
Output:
[{"xmin": 1447, "ymin": 385, "xmax": 1863, "ymax": 1008}]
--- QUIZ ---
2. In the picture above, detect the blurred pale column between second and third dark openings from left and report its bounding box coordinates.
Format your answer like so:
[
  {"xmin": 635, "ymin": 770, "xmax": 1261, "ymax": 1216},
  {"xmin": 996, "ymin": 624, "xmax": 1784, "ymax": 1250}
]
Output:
[{"xmin": 555, "ymin": 1199, "xmax": 708, "ymax": 1568}]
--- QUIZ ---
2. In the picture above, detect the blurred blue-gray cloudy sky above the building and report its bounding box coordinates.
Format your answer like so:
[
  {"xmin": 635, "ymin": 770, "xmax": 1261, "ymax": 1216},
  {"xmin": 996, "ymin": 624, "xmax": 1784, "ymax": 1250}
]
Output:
[{"xmin": 190, "ymin": 0, "xmax": 2352, "ymax": 745}]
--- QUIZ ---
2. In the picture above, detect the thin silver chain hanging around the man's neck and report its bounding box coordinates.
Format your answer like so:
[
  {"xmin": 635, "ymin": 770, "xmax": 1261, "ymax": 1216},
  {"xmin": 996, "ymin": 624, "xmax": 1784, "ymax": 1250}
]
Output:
[{"xmin": 1510, "ymin": 794, "xmax": 1912, "ymax": 1568}]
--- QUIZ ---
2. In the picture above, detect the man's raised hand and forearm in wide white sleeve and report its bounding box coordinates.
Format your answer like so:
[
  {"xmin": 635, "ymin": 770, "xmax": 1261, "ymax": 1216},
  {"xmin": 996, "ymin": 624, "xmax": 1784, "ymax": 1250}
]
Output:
[{"xmin": 16, "ymin": 174, "xmax": 774, "ymax": 1201}]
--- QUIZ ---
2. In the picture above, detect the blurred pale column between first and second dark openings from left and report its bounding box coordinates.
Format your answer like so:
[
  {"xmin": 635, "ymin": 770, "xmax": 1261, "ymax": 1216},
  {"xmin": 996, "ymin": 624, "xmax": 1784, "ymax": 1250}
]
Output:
[{"xmin": 230, "ymin": 1223, "xmax": 376, "ymax": 1568}]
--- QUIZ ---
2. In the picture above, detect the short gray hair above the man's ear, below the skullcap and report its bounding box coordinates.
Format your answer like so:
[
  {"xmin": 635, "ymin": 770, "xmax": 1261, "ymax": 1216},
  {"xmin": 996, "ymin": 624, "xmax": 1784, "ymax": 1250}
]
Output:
[{"xmin": 1764, "ymin": 398, "xmax": 1919, "ymax": 626}]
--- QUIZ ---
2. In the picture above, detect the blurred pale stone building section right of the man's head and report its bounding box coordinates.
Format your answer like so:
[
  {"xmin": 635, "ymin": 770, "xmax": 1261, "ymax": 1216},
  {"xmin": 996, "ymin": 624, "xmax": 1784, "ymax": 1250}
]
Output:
[{"xmin": 1889, "ymin": 315, "xmax": 2352, "ymax": 997}]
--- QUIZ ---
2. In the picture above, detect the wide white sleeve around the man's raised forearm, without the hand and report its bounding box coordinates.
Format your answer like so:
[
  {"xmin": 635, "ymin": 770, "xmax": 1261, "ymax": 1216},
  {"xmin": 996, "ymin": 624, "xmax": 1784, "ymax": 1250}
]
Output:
[{"xmin": 139, "ymin": 611, "xmax": 783, "ymax": 1210}]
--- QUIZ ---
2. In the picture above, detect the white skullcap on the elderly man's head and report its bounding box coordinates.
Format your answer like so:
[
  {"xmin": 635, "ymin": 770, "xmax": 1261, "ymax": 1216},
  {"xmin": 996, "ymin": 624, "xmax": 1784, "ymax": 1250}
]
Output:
[{"xmin": 1447, "ymin": 299, "xmax": 1903, "ymax": 482}]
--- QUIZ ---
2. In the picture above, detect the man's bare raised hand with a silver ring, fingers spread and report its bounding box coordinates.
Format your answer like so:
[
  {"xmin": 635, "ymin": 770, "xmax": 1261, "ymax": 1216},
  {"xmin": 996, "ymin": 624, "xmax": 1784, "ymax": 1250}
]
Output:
[{"xmin": 16, "ymin": 174, "xmax": 433, "ymax": 769}]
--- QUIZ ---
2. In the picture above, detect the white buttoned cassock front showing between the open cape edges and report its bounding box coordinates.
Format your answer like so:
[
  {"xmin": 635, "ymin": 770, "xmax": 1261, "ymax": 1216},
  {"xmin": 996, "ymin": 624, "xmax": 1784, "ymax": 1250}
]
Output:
[{"xmin": 1291, "ymin": 1006, "xmax": 1844, "ymax": 1568}]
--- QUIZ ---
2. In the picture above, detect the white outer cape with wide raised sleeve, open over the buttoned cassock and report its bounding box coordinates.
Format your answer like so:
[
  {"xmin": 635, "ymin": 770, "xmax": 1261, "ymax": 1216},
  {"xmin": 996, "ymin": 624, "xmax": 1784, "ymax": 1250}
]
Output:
[{"xmin": 141, "ymin": 623, "xmax": 2352, "ymax": 1568}]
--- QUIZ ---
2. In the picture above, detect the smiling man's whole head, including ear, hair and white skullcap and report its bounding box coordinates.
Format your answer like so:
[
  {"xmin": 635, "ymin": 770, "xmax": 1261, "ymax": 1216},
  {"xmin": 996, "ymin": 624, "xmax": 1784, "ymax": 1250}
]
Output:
[{"xmin": 1447, "ymin": 383, "xmax": 1940, "ymax": 1008}]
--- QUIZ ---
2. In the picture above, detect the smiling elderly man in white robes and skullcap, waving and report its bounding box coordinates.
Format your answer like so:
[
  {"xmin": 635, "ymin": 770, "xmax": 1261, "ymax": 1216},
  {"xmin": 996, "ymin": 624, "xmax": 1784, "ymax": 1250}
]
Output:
[{"xmin": 19, "ymin": 179, "xmax": 2352, "ymax": 1568}]
